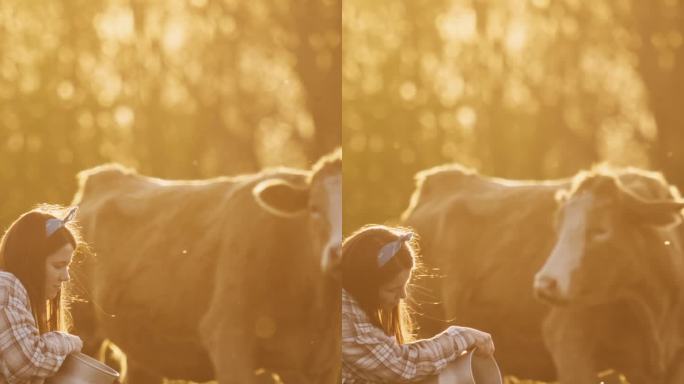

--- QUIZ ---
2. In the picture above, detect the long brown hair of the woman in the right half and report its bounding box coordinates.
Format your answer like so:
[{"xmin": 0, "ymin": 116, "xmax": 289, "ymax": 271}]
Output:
[{"xmin": 342, "ymin": 224, "xmax": 417, "ymax": 343}]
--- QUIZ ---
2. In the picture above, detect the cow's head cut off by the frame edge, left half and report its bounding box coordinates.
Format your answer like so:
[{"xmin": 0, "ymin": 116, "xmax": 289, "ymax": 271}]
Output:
[{"xmin": 252, "ymin": 150, "xmax": 342, "ymax": 273}]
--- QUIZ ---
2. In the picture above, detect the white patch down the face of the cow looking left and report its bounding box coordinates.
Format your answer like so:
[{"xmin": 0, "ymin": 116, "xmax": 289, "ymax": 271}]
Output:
[{"xmin": 534, "ymin": 194, "xmax": 594, "ymax": 302}]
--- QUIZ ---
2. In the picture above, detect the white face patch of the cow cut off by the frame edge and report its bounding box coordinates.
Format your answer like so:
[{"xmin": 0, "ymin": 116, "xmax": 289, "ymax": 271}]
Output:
[{"xmin": 321, "ymin": 175, "xmax": 342, "ymax": 272}]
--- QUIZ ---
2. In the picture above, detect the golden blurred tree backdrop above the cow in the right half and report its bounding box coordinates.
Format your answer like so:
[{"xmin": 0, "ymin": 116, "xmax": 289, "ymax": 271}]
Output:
[{"xmin": 342, "ymin": 0, "xmax": 683, "ymax": 233}]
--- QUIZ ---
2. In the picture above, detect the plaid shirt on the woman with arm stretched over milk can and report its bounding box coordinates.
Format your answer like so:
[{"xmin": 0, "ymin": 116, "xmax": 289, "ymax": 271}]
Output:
[{"xmin": 342, "ymin": 290, "xmax": 468, "ymax": 384}]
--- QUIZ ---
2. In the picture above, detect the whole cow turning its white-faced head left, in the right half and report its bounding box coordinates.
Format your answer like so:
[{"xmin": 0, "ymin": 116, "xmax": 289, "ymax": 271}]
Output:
[{"xmin": 402, "ymin": 165, "xmax": 684, "ymax": 384}]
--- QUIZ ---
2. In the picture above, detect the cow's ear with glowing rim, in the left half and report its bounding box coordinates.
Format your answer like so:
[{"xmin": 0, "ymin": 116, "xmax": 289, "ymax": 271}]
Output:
[{"xmin": 252, "ymin": 179, "xmax": 309, "ymax": 217}]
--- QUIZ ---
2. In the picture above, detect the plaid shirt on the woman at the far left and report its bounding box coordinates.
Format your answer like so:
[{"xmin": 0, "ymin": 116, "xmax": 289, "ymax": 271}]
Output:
[{"xmin": 0, "ymin": 271, "xmax": 78, "ymax": 384}]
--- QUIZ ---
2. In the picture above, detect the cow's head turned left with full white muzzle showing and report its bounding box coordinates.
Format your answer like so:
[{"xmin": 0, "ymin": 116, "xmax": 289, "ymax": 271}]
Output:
[{"xmin": 534, "ymin": 172, "xmax": 684, "ymax": 305}]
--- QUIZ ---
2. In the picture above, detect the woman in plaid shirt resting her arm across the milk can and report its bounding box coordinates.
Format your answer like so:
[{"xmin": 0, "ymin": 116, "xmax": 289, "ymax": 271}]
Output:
[{"xmin": 342, "ymin": 225, "xmax": 494, "ymax": 384}]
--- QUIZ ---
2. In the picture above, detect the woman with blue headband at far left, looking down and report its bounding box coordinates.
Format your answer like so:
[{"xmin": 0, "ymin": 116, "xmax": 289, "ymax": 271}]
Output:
[{"xmin": 0, "ymin": 208, "xmax": 83, "ymax": 384}]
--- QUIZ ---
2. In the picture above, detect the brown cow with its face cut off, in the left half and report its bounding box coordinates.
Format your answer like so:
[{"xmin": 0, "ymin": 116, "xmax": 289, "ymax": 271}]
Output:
[{"xmin": 71, "ymin": 150, "xmax": 342, "ymax": 384}]
